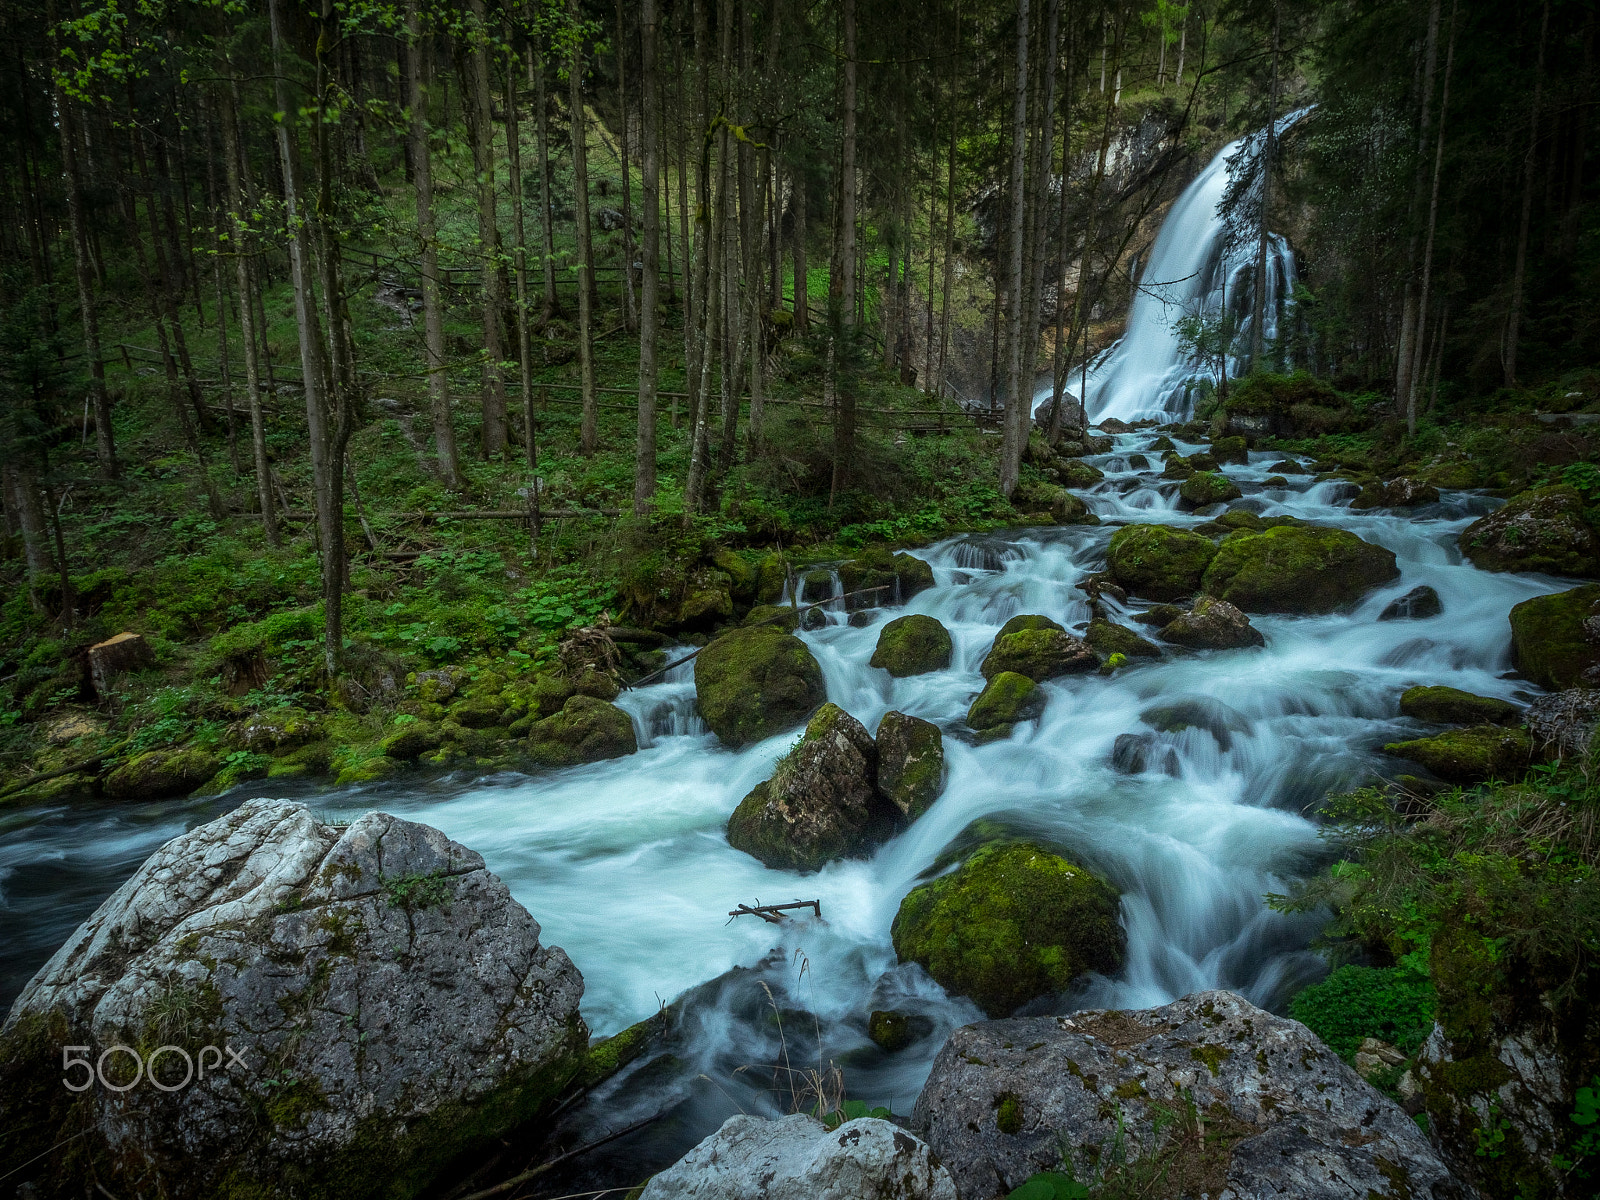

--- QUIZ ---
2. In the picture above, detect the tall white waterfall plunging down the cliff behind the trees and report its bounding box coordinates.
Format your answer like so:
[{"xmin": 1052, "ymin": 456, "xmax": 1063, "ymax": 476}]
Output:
[{"xmin": 1034, "ymin": 110, "xmax": 1304, "ymax": 421}]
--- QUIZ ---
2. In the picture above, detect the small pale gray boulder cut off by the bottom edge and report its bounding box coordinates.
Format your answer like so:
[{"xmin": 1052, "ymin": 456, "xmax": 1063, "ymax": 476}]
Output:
[{"xmin": 640, "ymin": 1114, "xmax": 957, "ymax": 1200}]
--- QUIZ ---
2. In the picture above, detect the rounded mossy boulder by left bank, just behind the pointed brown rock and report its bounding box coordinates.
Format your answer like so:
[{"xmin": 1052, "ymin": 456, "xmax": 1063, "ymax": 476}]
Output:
[{"xmin": 694, "ymin": 626, "xmax": 827, "ymax": 747}]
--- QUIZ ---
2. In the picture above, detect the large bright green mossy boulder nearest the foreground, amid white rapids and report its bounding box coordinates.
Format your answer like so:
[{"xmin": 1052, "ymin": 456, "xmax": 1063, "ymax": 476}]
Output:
[{"xmin": 890, "ymin": 842, "xmax": 1126, "ymax": 1018}]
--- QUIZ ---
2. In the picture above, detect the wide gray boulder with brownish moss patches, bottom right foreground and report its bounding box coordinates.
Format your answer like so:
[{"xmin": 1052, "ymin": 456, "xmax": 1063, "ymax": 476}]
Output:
[{"xmin": 914, "ymin": 992, "xmax": 1470, "ymax": 1200}]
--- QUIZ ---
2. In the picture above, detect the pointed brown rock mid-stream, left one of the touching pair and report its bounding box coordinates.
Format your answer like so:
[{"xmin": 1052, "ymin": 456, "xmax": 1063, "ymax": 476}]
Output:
[{"xmin": 728, "ymin": 704, "xmax": 898, "ymax": 870}]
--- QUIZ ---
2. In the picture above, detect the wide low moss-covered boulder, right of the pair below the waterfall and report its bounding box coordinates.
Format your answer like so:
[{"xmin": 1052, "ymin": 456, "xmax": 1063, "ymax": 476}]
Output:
[{"xmin": 1200, "ymin": 525, "xmax": 1400, "ymax": 613}]
